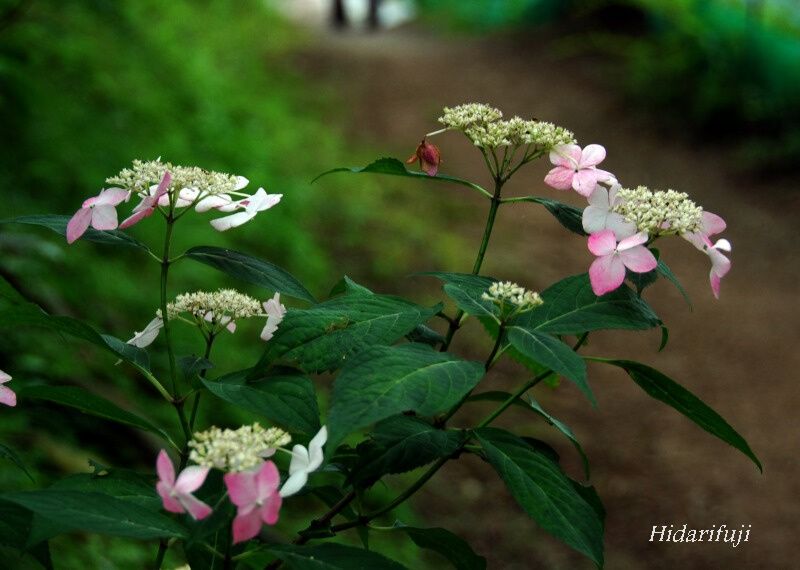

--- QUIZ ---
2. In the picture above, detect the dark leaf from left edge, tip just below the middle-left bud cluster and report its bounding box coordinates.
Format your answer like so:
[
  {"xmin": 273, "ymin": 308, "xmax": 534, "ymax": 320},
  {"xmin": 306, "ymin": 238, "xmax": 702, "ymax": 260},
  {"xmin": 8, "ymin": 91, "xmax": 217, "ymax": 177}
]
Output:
[{"xmin": 0, "ymin": 303, "xmax": 150, "ymax": 369}]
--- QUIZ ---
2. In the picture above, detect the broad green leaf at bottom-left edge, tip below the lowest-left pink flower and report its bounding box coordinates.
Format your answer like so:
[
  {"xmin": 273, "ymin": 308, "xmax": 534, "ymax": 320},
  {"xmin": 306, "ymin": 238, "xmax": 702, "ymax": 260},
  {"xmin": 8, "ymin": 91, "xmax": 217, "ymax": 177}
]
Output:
[{"xmin": 0, "ymin": 489, "xmax": 187, "ymax": 539}]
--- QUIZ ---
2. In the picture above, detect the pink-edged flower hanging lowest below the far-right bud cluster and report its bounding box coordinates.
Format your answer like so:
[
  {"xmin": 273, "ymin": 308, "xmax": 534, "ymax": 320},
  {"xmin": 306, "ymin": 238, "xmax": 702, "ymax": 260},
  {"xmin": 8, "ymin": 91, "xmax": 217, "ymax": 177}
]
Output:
[{"xmin": 589, "ymin": 230, "xmax": 658, "ymax": 297}]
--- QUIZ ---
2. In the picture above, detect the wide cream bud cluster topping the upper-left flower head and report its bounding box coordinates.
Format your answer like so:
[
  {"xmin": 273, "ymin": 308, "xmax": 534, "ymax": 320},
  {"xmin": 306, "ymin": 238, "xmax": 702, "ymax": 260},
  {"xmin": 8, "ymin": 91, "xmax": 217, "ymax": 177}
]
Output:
[{"xmin": 106, "ymin": 158, "xmax": 242, "ymax": 196}]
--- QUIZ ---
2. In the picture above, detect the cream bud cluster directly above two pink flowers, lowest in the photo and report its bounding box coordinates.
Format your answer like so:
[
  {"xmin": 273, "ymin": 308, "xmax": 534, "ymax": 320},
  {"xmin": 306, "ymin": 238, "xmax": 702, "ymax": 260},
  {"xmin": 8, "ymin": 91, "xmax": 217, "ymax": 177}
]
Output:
[{"xmin": 189, "ymin": 423, "xmax": 292, "ymax": 472}]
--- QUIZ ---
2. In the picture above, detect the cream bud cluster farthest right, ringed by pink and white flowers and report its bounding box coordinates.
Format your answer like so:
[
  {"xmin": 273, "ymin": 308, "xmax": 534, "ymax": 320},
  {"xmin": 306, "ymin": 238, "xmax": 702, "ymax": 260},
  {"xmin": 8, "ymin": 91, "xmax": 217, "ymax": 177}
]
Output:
[{"xmin": 612, "ymin": 186, "xmax": 703, "ymax": 236}]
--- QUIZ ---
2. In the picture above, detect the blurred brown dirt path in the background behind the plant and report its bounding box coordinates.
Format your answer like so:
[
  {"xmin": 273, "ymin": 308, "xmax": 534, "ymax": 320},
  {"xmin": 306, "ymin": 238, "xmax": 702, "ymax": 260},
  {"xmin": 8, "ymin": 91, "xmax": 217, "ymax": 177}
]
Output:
[{"xmin": 288, "ymin": 23, "xmax": 800, "ymax": 569}]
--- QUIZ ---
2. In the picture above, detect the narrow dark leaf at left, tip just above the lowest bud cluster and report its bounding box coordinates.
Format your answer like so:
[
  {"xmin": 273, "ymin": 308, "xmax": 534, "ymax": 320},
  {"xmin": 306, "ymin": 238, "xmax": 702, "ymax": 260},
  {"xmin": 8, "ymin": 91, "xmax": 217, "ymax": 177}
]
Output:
[{"xmin": 19, "ymin": 386, "xmax": 169, "ymax": 441}]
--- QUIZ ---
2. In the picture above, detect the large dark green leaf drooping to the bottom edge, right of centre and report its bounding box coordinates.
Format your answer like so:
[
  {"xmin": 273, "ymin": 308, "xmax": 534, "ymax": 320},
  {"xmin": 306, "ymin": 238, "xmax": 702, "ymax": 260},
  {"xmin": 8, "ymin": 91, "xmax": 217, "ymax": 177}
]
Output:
[{"xmin": 475, "ymin": 428, "xmax": 603, "ymax": 566}]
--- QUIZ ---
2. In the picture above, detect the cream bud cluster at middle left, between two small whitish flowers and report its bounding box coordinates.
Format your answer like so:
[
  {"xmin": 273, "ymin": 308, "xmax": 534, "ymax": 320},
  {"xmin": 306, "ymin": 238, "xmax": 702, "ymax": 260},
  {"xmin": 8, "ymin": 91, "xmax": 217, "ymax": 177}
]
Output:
[{"xmin": 158, "ymin": 289, "xmax": 263, "ymax": 324}]
